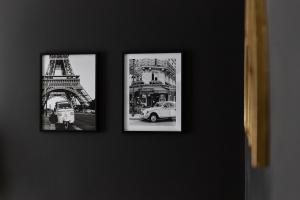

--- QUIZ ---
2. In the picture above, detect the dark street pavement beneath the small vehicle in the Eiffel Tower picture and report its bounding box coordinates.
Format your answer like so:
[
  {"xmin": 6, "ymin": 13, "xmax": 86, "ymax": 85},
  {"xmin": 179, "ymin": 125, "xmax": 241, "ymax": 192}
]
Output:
[{"xmin": 42, "ymin": 113, "xmax": 96, "ymax": 131}]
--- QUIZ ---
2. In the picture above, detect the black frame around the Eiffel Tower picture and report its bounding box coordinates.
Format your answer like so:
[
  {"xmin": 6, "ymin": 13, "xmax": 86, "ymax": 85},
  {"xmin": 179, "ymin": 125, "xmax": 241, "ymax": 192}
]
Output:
[{"xmin": 39, "ymin": 51, "xmax": 100, "ymax": 134}]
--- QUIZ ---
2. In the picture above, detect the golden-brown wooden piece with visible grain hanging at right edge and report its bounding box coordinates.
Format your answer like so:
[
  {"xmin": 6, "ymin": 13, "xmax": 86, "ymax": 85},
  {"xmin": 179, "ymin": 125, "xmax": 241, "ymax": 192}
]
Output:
[{"xmin": 244, "ymin": 0, "xmax": 269, "ymax": 168}]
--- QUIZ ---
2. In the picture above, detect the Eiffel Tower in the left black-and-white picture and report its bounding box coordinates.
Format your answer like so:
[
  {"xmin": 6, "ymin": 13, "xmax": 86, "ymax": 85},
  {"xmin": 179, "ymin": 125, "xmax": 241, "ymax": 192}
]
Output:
[{"xmin": 42, "ymin": 55, "xmax": 92, "ymax": 108}]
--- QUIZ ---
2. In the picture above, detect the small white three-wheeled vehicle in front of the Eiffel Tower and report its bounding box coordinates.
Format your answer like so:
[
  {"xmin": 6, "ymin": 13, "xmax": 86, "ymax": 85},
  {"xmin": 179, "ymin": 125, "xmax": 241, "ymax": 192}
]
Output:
[{"xmin": 54, "ymin": 101, "xmax": 75, "ymax": 129}]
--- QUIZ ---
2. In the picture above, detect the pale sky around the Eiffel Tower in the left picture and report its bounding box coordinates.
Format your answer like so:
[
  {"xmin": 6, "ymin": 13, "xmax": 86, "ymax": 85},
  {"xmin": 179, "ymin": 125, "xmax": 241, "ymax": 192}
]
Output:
[{"xmin": 42, "ymin": 54, "xmax": 96, "ymax": 109}]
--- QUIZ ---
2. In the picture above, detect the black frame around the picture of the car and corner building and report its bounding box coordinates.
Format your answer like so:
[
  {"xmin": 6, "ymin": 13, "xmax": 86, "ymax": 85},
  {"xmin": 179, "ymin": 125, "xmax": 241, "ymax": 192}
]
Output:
[{"xmin": 121, "ymin": 50, "xmax": 185, "ymax": 135}]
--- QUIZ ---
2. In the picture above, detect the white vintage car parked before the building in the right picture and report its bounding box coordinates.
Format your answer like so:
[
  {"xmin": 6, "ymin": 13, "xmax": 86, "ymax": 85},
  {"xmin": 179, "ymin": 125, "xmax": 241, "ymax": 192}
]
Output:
[{"xmin": 141, "ymin": 101, "xmax": 176, "ymax": 122}]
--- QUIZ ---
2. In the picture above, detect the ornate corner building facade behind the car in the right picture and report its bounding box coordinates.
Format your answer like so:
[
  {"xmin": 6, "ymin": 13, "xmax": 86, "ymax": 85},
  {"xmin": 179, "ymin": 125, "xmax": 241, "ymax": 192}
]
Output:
[{"xmin": 129, "ymin": 59, "xmax": 176, "ymax": 113}]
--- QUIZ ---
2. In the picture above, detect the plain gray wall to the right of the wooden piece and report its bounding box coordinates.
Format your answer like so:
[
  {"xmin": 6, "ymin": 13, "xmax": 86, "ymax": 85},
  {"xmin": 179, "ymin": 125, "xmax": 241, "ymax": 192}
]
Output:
[{"xmin": 246, "ymin": 0, "xmax": 300, "ymax": 200}]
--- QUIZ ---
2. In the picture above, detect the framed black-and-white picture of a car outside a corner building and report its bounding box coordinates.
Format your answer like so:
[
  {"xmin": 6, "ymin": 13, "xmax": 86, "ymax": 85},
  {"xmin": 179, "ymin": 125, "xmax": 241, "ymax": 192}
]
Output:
[{"xmin": 123, "ymin": 52, "xmax": 182, "ymax": 132}]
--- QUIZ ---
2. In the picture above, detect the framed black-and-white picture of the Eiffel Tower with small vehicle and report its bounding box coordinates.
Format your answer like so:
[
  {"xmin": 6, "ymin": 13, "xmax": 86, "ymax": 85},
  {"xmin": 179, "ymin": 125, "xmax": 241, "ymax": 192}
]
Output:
[{"xmin": 40, "ymin": 52, "xmax": 97, "ymax": 132}]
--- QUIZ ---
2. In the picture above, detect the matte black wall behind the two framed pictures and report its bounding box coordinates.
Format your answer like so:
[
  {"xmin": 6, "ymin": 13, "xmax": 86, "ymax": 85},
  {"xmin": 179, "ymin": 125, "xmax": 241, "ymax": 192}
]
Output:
[{"xmin": 0, "ymin": 0, "xmax": 244, "ymax": 200}]
